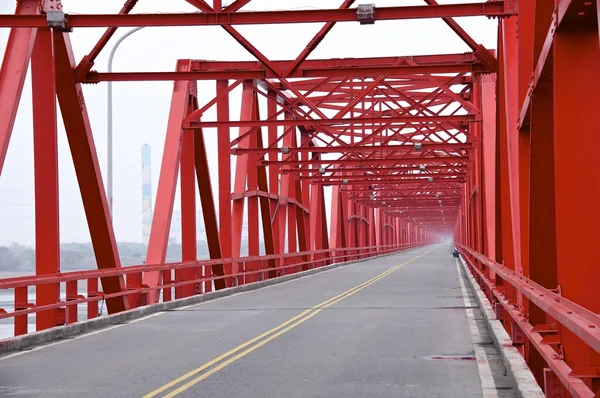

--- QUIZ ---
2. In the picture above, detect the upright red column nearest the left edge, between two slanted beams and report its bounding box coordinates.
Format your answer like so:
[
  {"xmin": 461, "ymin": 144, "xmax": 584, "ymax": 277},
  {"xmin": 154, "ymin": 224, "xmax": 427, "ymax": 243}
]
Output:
[{"xmin": 31, "ymin": 28, "xmax": 60, "ymax": 330}]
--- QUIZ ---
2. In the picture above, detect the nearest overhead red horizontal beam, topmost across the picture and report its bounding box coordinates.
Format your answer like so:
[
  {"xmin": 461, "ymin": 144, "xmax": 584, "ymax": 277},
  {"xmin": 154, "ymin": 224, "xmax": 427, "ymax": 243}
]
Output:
[{"xmin": 0, "ymin": 0, "xmax": 516, "ymax": 28}]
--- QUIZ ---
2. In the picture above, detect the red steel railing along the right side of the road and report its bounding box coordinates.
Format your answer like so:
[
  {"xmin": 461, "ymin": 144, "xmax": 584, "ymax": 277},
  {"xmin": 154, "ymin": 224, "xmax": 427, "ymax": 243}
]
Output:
[{"xmin": 457, "ymin": 245, "xmax": 600, "ymax": 398}]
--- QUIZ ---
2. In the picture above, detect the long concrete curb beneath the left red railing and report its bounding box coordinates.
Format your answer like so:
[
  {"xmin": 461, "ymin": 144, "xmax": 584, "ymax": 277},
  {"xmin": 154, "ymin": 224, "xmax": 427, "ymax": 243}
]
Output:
[{"xmin": 0, "ymin": 248, "xmax": 414, "ymax": 355}]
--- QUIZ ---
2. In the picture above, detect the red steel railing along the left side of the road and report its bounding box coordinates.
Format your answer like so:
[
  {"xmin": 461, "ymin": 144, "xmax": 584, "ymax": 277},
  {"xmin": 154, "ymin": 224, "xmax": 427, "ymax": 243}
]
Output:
[{"xmin": 0, "ymin": 244, "xmax": 421, "ymax": 340}]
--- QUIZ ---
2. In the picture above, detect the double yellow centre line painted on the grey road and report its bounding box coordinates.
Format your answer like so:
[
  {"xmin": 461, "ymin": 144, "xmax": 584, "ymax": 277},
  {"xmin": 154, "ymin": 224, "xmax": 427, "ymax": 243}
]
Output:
[{"xmin": 144, "ymin": 250, "xmax": 431, "ymax": 398}]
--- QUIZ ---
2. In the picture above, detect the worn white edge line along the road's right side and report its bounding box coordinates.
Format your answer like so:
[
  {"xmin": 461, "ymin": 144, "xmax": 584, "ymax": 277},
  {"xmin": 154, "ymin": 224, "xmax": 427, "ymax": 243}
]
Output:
[{"xmin": 455, "ymin": 260, "xmax": 499, "ymax": 398}]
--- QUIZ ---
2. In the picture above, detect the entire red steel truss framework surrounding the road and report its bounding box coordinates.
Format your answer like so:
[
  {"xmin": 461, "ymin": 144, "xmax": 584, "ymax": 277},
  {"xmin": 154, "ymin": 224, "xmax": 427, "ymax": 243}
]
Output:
[{"xmin": 0, "ymin": 0, "xmax": 600, "ymax": 397}]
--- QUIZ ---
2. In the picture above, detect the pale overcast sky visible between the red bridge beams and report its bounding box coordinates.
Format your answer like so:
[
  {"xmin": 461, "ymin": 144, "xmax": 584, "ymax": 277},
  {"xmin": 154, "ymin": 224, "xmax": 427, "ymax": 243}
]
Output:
[{"xmin": 0, "ymin": 0, "xmax": 497, "ymax": 245}]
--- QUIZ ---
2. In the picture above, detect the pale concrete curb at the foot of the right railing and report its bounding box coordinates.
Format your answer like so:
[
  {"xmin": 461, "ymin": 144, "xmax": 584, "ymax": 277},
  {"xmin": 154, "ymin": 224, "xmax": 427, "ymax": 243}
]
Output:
[{"xmin": 459, "ymin": 256, "xmax": 545, "ymax": 398}]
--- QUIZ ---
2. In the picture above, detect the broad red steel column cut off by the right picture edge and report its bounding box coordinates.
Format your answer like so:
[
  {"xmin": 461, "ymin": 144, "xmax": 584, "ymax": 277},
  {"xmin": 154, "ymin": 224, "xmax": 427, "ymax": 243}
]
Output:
[{"xmin": 553, "ymin": 24, "xmax": 600, "ymax": 392}]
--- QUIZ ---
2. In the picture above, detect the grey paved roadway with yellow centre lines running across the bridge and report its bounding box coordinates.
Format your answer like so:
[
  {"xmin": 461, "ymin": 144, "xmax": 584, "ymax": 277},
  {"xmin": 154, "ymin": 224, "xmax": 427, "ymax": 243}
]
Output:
[{"xmin": 0, "ymin": 244, "xmax": 514, "ymax": 398}]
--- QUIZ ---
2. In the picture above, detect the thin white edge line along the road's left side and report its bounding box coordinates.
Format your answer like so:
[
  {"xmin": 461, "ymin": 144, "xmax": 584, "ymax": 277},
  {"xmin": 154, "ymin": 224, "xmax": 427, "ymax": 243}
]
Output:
[{"xmin": 0, "ymin": 248, "xmax": 432, "ymax": 362}]
